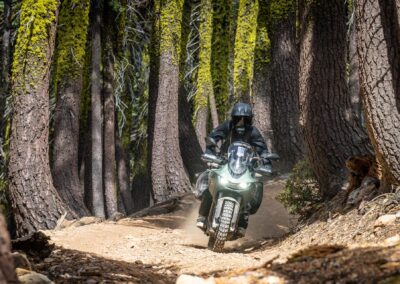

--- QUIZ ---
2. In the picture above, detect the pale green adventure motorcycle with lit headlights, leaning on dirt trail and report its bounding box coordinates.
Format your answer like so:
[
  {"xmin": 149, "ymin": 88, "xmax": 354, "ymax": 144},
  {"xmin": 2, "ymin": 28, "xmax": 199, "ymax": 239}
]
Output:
[{"xmin": 196, "ymin": 139, "xmax": 279, "ymax": 252}]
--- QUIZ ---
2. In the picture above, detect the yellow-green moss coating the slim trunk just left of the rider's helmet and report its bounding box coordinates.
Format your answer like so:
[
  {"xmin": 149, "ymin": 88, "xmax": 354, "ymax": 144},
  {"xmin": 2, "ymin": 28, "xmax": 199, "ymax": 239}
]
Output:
[{"xmin": 194, "ymin": 0, "xmax": 213, "ymax": 117}]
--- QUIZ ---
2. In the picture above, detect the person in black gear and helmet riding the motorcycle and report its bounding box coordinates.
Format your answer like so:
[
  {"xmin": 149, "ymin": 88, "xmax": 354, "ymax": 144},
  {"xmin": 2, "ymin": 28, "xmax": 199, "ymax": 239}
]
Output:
[{"xmin": 196, "ymin": 102, "xmax": 272, "ymax": 236}]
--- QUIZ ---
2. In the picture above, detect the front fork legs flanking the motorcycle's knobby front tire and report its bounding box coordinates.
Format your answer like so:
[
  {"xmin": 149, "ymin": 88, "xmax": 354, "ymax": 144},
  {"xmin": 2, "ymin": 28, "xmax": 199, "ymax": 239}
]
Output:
[{"xmin": 208, "ymin": 193, "xmax": 241, "ymax": 233}]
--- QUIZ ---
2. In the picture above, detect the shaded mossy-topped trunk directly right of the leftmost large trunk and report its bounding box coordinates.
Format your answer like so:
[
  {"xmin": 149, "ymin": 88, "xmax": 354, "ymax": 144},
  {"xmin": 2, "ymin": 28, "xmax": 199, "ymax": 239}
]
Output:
[{"xmin": 52, "ymin": 0, "xmax": 90, "ymax": 216}]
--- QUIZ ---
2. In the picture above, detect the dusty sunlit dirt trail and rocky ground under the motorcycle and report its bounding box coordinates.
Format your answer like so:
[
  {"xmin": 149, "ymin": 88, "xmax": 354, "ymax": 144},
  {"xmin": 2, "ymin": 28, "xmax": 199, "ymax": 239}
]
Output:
[{"xmin": 19, "ymin": 179, "xmax": 400, "ymax": 283}]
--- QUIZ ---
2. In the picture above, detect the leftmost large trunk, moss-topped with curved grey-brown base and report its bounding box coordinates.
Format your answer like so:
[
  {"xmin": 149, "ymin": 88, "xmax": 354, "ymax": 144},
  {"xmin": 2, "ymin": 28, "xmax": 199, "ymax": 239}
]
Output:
[{"xmin": 9, "ymin": 0, "xmax": 76, "ymax": 236}]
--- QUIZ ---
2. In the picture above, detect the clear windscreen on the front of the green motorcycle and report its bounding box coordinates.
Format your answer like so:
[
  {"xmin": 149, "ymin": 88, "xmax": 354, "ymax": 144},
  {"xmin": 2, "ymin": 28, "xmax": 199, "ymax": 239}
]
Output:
[{"xmin": 228, "ymin": 143, "xmax": 251, "ymax": 176}]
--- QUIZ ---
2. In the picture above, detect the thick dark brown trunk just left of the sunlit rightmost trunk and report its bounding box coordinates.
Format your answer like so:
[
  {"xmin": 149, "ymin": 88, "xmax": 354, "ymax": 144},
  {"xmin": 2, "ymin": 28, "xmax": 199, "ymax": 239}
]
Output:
[{"xmin": 300, "ymin": 0, "xmax": 370, "ymax": 199}]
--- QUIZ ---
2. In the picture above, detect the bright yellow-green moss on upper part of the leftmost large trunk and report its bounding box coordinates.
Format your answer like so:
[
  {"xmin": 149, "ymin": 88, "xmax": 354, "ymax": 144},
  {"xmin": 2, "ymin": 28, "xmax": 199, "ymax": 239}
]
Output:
[{"xmin": 12, "ymin": 0, "xmax": 58, "ymax": 94}]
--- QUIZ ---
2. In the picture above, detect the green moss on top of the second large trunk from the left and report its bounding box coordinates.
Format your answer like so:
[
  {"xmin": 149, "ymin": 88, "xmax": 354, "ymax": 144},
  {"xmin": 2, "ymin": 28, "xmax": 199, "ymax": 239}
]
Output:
[{"xmin": 55, "ymin": 0, "xmax": 90, "ymax": 85}]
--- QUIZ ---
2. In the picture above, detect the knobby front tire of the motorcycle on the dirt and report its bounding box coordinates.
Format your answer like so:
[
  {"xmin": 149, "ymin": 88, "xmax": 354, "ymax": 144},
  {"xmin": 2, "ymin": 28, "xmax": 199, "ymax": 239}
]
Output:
[{"xmin": 208, "ymin": 200, "xmax": 235, "ymax": 252}]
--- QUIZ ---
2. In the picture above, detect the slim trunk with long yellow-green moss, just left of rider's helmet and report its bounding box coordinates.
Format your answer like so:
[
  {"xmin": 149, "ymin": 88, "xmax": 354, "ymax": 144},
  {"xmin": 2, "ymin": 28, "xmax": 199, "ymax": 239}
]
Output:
[{"xmin": 194, "ymin": 0, "xmax": 214, "ymax": 149}]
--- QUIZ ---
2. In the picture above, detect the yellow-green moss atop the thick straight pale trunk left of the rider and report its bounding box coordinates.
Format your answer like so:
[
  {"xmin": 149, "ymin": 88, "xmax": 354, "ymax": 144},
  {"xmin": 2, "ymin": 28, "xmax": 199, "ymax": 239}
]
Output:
[{"xmin": 159, "ymin": 0, "xmax": 183, "ymax": 64}]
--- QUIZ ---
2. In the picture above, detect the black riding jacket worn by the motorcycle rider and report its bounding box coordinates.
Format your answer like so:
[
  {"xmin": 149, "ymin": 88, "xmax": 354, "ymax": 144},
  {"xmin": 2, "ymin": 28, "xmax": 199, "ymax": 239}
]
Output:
[{"xmin": 206, "ymin": 120, "xmax": 268, "ymax": 157}]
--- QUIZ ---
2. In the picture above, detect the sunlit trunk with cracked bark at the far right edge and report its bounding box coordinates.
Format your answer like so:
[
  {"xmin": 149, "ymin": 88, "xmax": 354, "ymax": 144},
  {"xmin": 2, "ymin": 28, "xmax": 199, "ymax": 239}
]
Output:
[{"xmin": 355, "ymin": 0, "xmax": 400, "ymax": 189}]
